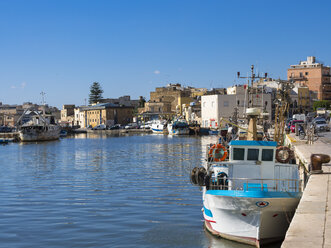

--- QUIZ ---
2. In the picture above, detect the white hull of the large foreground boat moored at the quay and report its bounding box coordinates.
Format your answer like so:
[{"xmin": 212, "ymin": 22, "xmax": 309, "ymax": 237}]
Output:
[{"xmin": 203, "ymin": 191, "xmax": 301, "ymax": 247}]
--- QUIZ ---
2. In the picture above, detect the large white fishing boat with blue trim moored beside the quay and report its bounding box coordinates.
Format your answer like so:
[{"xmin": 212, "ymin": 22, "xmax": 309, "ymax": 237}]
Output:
[{"xmin": 191, "ymin": 108, "xmax": 302, "ymax": 247}]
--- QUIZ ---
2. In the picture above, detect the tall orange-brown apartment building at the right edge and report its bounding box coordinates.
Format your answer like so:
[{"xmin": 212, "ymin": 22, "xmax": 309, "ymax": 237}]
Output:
[{"xmin": 287, "ymin": 56, "xmax": 331, "ymax": 100}]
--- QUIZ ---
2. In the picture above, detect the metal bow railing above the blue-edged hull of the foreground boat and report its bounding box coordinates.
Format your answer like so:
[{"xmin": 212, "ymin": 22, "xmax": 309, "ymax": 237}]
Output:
[{"xmin": 206, "ymin": 177, "xmax": 302, "ymax": 192}]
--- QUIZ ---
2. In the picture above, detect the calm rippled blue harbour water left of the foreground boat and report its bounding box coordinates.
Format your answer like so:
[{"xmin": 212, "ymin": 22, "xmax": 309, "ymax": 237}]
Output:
[{"xmin": 0, "ymin": 134, "xmax": 280, "ymax": 248}]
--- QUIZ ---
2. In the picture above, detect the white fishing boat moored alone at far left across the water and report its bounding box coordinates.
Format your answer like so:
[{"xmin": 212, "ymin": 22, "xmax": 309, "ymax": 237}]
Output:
[{"xmin": 18, "ymin": 110, "xmax": 61, "ymax": 141}]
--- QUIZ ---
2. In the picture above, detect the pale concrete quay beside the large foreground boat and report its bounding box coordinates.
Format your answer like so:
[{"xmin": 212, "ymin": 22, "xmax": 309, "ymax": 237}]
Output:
[{"xmin": 281, "ymin": 132, "xmax": 331, "ymax": 248}]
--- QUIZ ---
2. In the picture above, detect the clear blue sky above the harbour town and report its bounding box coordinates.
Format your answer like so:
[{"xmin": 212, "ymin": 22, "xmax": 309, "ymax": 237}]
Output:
[{"xmin": 0, "ymin": 0, "xmax": 331, "ymax": 108}]
